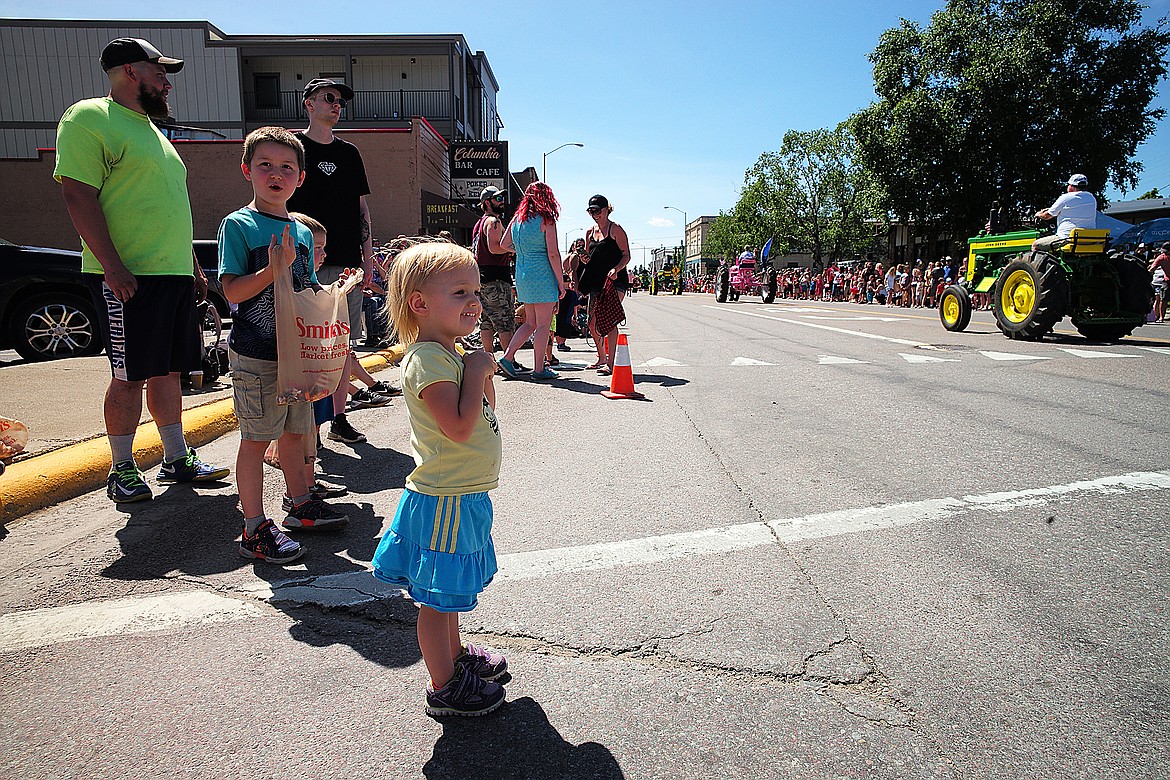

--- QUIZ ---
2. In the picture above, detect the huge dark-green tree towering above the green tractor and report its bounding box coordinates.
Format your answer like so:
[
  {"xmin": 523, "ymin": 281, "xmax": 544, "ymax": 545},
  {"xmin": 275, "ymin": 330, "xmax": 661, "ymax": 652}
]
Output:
[{"xmin": 854, "ymin": 0, "xmax": 1170, "ymax": 236}]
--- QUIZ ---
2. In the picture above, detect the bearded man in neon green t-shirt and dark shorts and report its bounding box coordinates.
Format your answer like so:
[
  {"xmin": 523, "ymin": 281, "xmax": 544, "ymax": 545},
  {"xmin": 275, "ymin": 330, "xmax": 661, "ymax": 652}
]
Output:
[{"xmin": 53, "ymin": 37, "xmax": 229, "ymax": 503}]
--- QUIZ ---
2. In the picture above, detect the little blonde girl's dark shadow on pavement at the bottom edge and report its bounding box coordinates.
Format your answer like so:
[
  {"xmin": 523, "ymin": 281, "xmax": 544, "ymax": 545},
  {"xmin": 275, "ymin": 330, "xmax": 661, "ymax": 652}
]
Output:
[{"xmin": 422, "ymin": 696, "xmax": 626, "ymax": 780}]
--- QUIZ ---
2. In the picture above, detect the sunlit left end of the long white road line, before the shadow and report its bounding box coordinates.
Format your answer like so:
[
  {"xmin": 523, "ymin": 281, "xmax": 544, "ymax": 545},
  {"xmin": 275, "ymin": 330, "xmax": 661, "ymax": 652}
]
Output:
[{"xmin": 0, "ymin": 591, "xmax": 260, "ymax": 653}]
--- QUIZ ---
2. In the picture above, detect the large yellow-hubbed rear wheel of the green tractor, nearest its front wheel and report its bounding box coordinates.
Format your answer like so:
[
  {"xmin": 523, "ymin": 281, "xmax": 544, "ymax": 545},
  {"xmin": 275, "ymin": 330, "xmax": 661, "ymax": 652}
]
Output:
[{"xmin": 991, "ymin": 251, "xmax": 1068, "ymax": 341}]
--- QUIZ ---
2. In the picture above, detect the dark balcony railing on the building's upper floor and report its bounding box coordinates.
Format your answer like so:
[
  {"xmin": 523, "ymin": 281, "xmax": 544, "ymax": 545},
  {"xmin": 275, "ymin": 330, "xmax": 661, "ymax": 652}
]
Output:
[{"xmin": 243, "ymin": 89, "xmax": 452, "ymax": 122}]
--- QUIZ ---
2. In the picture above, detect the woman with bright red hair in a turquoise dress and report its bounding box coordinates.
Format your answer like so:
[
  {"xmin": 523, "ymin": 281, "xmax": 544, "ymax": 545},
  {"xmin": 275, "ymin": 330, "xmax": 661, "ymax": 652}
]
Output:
[{"xmin": 498, "ymin": 181, "xmax": 565, "ymax": 379}]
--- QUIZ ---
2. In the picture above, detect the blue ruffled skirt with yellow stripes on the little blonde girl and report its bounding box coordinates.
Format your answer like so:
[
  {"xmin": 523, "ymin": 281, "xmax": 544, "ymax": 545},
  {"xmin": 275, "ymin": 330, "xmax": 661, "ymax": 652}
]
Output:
[{"xmin": 373, "ymin": 490, "xmax": 496, "ymax": 612}]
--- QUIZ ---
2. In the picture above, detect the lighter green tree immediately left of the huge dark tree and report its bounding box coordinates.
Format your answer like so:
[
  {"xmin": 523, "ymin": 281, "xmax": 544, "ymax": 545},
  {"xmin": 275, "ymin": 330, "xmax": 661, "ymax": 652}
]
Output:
[{"xmin": 746, "ymin": 123, "xmax": 886, "ymax": 263}]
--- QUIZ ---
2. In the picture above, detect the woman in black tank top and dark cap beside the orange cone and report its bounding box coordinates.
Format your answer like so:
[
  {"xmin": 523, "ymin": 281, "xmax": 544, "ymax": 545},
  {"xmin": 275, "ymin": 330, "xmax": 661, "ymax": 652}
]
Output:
[{"xmin": 580, "ymin": 195, "xmax": 629, "ymax": 374}]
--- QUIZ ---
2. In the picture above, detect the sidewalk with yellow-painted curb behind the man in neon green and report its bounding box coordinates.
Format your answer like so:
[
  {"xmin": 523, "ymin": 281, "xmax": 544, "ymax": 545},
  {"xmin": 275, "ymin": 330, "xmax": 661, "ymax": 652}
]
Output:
[{"xmin": 0, "ymin": 347, "xmax": 399, "ymax": 525}]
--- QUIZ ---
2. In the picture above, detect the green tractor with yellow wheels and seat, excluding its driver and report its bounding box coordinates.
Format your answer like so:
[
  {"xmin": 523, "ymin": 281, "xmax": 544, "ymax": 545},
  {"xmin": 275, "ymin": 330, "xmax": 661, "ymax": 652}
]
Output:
[{"xmin": 938, "ymin": 210, "xmax": 1154, "ymax": 341}]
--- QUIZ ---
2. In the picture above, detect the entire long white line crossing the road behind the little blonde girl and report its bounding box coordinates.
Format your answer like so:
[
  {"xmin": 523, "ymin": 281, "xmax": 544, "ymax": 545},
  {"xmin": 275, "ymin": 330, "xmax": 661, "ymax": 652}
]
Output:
[{"xmin": 9, "ymin": 470, "xmax": 1170, "ymax": 653}]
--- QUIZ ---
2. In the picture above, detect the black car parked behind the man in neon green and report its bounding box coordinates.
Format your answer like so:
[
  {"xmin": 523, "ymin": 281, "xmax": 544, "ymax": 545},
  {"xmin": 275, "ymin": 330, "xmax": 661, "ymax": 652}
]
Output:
[{"xmin": 0, "ymin": 239, "xmax": 228, "ymax": 360}]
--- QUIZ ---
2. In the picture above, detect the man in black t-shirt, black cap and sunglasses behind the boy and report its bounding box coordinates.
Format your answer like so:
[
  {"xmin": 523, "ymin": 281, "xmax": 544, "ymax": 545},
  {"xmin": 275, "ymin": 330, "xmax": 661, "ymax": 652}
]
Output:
[{"xmin": 289, "ymin": 78, "xmax": 388, "ymax": 444}]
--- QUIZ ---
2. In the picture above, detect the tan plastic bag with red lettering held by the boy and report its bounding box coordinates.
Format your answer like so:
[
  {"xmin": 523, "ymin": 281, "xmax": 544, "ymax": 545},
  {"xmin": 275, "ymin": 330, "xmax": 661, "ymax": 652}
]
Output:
[{"xmin": 273, "ymin": 263, "xmax": 362, "ymax": 403}]
